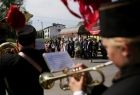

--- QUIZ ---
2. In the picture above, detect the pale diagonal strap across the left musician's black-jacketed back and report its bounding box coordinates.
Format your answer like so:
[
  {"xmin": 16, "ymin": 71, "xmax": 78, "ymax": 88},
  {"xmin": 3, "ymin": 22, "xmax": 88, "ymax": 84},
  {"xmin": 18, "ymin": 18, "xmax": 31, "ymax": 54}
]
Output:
[{"xmin": 18, "ymin": 52, "xmax": 42, "ymax": 73}]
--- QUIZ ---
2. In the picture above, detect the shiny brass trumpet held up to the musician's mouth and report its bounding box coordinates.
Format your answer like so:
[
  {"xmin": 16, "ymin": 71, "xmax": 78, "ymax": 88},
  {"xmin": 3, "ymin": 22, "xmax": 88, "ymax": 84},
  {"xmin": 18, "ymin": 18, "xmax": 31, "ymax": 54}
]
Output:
[{"xmin": 39, "ymin": 61, "xmax": 112, "ymax": 90}]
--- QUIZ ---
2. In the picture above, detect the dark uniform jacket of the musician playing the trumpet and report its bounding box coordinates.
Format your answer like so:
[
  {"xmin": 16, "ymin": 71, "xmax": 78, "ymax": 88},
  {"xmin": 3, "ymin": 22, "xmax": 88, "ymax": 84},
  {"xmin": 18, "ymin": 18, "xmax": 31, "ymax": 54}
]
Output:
[{"xmin": 103, "ymin": 64, "xmax": 140, "ymax": 95}]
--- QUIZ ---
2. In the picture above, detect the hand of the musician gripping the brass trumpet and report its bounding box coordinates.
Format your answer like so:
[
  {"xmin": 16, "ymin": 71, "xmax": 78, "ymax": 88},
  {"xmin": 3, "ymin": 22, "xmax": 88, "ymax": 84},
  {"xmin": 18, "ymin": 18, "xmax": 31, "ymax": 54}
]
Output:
[{"xmin": 69, "ymin": 64, "xmax": 92, "ymax": 92}]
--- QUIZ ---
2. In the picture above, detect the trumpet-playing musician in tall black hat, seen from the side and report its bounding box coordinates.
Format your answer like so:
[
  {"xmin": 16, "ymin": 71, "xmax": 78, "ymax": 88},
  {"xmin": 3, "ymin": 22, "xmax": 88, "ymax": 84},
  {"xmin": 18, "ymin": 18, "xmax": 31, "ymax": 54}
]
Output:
[{"xmin": 70, "ymin": 0, "xmax": 140, "ymax": 95}]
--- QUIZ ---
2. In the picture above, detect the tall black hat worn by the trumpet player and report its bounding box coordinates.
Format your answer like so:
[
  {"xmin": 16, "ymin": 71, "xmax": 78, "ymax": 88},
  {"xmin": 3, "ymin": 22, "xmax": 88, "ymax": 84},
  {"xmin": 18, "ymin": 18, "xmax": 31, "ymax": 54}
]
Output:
[{"xmin": 100, "ymin": 0, "xmax": 140, "ymax": 38}]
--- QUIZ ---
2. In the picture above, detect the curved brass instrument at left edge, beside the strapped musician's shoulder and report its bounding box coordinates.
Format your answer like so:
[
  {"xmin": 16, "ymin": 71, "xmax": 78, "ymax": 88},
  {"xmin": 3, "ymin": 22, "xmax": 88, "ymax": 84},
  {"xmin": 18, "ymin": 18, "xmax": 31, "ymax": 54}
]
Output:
[{"xmin": 0, "ymin": 42, "xmax": 18, "ymax": 55}]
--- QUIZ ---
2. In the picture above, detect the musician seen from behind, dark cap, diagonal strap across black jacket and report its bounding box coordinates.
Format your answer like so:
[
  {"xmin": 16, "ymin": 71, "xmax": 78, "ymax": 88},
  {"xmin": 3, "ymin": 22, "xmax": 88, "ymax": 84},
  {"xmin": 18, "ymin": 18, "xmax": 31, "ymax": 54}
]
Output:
[{"xmin": 0, "ymin": 25, "xmax": 50, "ymax": 95}]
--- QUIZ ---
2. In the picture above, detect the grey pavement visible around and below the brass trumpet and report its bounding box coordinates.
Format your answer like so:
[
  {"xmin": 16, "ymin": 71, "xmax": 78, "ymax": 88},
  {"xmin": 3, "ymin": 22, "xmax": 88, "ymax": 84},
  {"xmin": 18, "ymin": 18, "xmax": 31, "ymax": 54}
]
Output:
[{"xmin": 44, "ymin": 58, "xmax": 117, "ymax": 95}]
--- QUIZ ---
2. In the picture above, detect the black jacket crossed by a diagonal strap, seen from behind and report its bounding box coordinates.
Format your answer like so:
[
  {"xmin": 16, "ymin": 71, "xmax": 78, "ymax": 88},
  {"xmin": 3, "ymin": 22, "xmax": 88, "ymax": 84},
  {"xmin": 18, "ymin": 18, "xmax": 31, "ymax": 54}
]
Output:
[{"xmin": 0, "ymin": 49, "xmax": 49, "ymax": 95}]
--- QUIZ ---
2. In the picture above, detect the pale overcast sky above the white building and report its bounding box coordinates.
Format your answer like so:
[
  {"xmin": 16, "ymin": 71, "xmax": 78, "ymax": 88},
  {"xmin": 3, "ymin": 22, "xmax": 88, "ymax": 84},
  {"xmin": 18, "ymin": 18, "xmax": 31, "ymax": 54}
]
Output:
[{"xmin": 24, "ymin": 0, "xmax": 81, "ymax": 30}]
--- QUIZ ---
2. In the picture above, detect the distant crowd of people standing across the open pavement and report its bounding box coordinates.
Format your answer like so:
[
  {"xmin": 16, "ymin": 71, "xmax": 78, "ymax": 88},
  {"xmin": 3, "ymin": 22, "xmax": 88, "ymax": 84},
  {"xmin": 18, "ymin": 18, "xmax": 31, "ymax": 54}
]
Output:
[{"xmin": 41, "ymin": 37, "xmax": 107, "ymax": 59}]
